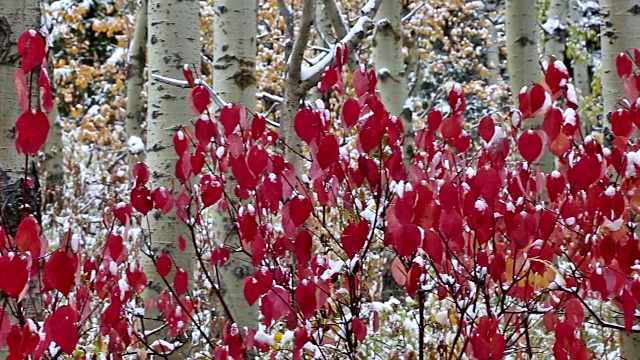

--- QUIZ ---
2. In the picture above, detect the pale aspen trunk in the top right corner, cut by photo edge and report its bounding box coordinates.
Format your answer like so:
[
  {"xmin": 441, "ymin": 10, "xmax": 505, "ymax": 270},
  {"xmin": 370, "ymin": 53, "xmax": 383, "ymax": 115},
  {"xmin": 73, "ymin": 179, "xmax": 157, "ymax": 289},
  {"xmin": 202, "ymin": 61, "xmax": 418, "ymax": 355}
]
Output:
[{"xmin": 600, "ymin": 0, "xmax": 640, "ymax": 127}]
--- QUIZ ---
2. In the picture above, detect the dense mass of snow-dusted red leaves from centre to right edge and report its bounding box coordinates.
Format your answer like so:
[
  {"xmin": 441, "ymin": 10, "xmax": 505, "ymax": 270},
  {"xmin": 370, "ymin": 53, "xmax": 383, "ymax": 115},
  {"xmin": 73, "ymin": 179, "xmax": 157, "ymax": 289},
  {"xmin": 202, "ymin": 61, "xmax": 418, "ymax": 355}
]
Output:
[{"xmin": 132, "ymin": 47, "xmax": 640, "ymax": 359}]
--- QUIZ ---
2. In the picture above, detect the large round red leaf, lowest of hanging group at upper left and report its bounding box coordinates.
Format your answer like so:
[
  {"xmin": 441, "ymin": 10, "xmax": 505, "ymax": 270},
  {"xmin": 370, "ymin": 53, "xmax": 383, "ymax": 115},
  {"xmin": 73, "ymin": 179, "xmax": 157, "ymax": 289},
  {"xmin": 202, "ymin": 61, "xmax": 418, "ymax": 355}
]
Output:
[{"xmin": 15, "ymin": 110, "xmax": 49, "ymax": 155}]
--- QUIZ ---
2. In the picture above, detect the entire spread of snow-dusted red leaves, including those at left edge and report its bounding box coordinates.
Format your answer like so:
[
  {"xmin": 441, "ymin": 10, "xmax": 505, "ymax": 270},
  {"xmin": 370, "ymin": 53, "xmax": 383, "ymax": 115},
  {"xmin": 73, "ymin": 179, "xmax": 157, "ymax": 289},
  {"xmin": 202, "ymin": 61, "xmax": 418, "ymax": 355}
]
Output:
[{"xmin": 6, "ymin": 22, "xmax": 640, "ymax": 359}]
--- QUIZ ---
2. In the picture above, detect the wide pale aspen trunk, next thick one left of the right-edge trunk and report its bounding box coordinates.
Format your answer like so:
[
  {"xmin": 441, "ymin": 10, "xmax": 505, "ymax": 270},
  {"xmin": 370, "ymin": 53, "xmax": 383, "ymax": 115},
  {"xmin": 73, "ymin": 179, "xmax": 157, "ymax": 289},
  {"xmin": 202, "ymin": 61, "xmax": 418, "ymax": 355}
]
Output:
[{"xmin": 506, "ymin": 0, "xmax": 541, "ymax": 111}]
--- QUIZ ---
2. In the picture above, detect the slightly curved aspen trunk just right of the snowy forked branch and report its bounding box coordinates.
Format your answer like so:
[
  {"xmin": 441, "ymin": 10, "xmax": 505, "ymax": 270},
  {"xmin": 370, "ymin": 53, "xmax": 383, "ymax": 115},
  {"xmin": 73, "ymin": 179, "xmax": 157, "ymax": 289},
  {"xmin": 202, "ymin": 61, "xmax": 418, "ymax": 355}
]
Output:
[{"xmin": 373, "ymin": 0, "xmax": 413, "ymax": 159}]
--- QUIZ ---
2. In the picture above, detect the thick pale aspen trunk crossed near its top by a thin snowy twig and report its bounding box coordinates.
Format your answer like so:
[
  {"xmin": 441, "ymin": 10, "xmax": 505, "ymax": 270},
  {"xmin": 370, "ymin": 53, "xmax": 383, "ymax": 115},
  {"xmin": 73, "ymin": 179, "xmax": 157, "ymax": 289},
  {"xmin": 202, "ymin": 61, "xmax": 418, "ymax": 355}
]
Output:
[{"xmin": 144, "ymin": 0, "xmax": 200, "ymax": 359}]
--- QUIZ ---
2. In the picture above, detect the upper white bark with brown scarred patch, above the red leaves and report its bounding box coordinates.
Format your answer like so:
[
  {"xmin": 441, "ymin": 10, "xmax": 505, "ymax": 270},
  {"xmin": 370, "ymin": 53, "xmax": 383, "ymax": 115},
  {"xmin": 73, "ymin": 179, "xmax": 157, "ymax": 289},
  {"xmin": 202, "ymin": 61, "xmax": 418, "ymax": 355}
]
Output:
[{"xmin": 213, "ymin": 0, "xmax": 258, "ymax": 111}]
